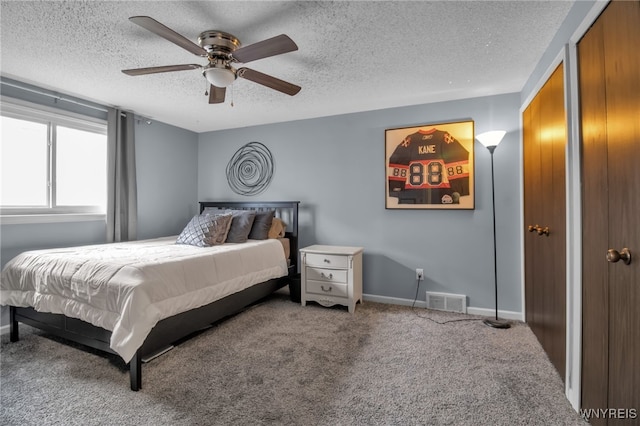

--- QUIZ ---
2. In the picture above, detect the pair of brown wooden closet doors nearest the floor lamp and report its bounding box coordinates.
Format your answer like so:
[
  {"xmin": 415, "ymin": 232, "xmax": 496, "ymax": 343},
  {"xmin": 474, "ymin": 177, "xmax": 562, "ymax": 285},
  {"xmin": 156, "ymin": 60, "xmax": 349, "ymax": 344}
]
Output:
[{"xmin": 523, "ymin": 64, "xmax": 566, "ymax": 380}]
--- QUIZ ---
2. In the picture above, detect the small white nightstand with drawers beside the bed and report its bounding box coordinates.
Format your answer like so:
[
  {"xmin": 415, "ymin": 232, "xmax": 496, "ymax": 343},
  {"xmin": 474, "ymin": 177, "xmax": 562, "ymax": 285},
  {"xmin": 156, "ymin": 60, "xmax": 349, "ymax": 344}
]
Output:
[{"xmin": 300, "ymin": 245, "xmax": 364, "ymax": 313}]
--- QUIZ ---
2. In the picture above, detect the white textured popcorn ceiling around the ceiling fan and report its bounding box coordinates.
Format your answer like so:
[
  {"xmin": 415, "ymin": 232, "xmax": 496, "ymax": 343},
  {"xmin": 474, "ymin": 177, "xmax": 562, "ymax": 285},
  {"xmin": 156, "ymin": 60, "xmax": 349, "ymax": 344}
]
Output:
[{"xmin": 0, "ymin": 1, "xmax": 573, "ymax": 132}]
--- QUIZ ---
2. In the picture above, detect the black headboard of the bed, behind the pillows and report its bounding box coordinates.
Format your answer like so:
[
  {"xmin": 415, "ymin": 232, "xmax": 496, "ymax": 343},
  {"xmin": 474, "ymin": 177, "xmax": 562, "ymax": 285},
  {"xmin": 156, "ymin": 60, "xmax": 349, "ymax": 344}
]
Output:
[{"xmin": 200, "ymin": 201, "xmax": 300, "ymax": 275}]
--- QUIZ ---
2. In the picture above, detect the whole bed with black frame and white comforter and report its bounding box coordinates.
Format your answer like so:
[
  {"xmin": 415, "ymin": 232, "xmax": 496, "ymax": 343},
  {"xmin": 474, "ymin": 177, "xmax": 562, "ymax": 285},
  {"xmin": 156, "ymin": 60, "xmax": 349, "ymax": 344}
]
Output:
[{"xmin": 2, "ymin": 201, "xmax": 299, "ymax": 391}]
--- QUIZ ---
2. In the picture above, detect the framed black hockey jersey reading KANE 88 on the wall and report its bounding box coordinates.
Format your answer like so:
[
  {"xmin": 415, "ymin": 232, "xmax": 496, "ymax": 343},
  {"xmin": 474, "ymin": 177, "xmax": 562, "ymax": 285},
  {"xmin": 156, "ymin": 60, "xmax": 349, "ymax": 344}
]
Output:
[{"xmin": 385, "ymin": 121, "xmax": 475, "ymax": 209}]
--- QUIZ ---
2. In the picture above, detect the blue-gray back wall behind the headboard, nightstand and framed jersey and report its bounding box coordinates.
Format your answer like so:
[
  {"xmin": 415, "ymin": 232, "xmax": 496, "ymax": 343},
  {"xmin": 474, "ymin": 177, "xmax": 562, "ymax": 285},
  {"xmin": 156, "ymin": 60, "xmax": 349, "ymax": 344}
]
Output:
[{"xmin": 198, "ymin": 93, "xmax": 522, "ymax": 312}]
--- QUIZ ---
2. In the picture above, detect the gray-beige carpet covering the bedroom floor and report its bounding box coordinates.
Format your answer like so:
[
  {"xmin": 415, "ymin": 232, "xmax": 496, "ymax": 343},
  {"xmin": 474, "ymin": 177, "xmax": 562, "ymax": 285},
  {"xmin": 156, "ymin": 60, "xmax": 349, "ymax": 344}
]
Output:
[{"xmin": 0, "ymin": 291, "xmax": 586, "ymax": 426}]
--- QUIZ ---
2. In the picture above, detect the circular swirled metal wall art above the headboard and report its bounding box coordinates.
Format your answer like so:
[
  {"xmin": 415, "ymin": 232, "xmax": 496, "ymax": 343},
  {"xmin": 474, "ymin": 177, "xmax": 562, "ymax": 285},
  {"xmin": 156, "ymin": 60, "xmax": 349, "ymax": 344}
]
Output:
[{"xmin": 227, "ymin": 142, "xmax": 274, "ymax": 195}]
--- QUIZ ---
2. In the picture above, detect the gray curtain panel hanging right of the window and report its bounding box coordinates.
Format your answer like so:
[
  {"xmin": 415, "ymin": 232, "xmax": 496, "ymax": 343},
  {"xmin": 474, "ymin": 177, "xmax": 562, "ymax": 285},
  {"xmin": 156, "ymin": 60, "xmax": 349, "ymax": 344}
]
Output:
[{"xmin": 107, "ymin": 108, "xmax": 138, "ymax": 243}]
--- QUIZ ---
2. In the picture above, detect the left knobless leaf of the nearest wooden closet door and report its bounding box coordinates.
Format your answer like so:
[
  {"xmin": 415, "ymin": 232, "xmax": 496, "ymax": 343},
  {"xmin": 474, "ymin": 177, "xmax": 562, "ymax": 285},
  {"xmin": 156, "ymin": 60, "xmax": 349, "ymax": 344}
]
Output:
[{"xmin": 578, "ymin": 14, "xmax": 609, "ymax": 416}]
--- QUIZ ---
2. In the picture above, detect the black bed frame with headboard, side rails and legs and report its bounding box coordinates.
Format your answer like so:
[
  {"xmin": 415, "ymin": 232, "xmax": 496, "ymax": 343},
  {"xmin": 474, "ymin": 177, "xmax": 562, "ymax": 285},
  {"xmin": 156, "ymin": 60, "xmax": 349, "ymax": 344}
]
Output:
[{"xmin": 9, "ymin": 201, "xmax": 299, "ymax": 391}]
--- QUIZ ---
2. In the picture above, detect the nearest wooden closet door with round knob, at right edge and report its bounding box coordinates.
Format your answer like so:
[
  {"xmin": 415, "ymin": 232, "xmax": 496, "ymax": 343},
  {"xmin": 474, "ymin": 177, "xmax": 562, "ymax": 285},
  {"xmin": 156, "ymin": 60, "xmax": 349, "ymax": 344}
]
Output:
[{"xmin": 578, "ymin": 1, "xmax": 640, "ymax": 424}]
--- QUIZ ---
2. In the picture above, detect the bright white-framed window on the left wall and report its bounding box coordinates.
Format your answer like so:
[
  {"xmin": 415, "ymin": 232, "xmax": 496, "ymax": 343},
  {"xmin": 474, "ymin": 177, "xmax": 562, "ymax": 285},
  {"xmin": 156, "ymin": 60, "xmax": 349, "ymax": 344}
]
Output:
[{"xmin": 0, "ymin": 99, "xmax": 107, "ymax": 215}]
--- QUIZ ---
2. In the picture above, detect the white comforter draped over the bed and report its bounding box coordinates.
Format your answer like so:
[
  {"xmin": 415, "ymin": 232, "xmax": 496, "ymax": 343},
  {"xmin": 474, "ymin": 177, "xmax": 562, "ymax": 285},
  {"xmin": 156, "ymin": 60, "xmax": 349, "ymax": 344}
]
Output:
[{"xmin": 0, "ymin": 237, "xmax": 287, "ymax": 362}]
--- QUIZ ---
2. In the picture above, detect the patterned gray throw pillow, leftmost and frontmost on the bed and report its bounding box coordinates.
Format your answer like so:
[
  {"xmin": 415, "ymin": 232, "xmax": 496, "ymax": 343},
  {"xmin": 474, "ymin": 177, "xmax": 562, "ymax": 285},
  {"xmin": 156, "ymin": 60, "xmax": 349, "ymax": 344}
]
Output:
[{"xmin": 176, "ymin": 214, "xmax": 233, "ymax": 247}]
